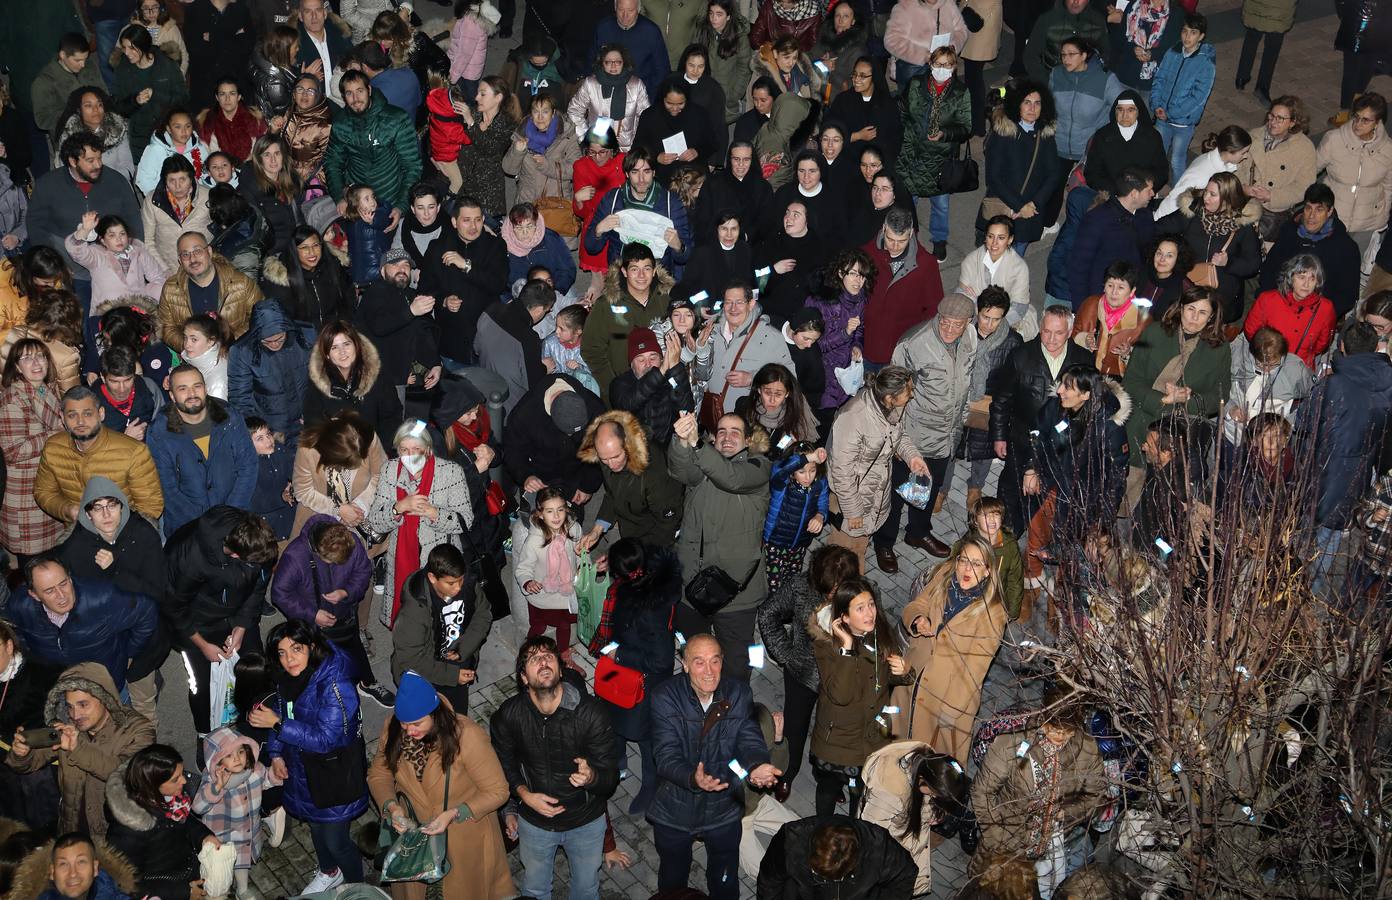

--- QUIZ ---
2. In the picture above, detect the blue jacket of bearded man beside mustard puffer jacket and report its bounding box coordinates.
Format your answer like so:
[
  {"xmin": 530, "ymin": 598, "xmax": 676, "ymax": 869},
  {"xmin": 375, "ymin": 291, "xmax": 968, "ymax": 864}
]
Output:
[{"xmin": 145, "ymin": 396, "xmax": 258, "ymax": 534}]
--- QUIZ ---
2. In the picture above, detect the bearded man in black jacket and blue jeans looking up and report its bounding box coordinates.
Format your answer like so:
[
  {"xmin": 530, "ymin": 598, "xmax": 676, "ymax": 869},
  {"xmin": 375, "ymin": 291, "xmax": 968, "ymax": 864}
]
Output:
[{"xmin": 489, "ymin": 636, "xmax": 619, "ymax": 897}]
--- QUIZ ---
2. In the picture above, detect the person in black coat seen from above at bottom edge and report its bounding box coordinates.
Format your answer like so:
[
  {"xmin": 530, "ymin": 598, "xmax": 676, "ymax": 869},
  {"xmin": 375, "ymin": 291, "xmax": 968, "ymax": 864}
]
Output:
[{"xmin": 759, "ymin": 815, "xmax": 919, "ymax": 900}]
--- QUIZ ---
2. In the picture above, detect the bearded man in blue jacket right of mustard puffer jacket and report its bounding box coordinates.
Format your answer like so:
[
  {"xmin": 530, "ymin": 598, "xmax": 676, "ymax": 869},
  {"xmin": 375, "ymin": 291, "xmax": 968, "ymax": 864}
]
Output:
[{"xmin": 145, "ymin": 363, "xmax": 258, "ymax": 534}]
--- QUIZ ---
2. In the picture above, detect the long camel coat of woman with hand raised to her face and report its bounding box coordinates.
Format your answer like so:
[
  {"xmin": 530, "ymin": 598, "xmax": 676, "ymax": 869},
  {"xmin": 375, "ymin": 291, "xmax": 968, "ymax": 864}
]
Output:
[{"xmin": 891, "ymin": 561, "xmax": 1009, "ymax": 765}]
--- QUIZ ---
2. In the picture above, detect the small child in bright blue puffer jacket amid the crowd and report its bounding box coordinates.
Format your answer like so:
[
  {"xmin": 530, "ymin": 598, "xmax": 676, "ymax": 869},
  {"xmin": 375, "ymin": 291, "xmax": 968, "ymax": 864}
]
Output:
[{"xmin": 764, "ymin": 438, "xmax": 831, "ymax": 595}]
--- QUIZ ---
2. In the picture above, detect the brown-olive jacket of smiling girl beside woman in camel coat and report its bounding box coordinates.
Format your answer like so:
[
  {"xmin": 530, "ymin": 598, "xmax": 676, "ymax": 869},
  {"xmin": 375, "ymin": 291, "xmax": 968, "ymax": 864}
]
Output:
[{"xmin": 805, "ymin": 604, "xmax": 913, "ymax": 766}]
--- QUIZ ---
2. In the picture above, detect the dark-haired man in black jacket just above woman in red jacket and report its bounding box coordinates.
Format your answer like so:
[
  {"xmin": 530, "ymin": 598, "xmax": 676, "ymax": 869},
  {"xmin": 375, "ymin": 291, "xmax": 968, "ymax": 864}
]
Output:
[{"xmin": 1258, "ymin": 181, "xmax": 1358, "ymax": 319}]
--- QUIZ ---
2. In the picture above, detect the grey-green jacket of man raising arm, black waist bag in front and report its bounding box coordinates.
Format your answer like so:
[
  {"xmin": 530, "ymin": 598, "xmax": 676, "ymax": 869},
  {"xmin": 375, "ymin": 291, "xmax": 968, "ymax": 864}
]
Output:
[{"xmin": 667, "ymin": 439, "xmax": 782, "ymax": 612}]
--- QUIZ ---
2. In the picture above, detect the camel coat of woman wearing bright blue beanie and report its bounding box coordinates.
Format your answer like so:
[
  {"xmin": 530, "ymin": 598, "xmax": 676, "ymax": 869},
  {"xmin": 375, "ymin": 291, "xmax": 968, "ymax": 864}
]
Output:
[{"xmin": 367, "ymin": 700, "xmax": 516, "ymax": 900}]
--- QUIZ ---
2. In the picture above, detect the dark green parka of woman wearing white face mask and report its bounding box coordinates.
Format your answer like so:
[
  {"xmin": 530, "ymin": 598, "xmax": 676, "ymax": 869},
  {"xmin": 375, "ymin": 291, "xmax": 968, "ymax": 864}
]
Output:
[{"xmin": 898, "ymin": 72, "xmax": 972, "ymax": 198}]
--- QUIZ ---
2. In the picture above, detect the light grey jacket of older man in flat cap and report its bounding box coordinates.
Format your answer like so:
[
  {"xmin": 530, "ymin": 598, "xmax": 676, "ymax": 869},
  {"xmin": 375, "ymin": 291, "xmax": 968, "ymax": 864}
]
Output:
[{"xmin": 889, "ymin": 316, "xmax": 977, "ymax": 459}]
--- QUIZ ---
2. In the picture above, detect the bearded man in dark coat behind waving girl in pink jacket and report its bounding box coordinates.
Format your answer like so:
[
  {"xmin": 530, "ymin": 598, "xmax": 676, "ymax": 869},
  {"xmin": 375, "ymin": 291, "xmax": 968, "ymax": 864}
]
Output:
[{"xmin": 28, "ymin": 131, "xmax": 145, "ymax": 303}]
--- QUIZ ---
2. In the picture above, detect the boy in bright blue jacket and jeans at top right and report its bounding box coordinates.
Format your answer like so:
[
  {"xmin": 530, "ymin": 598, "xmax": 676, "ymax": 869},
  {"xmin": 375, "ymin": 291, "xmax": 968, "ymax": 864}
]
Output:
[{"xmin": 1150, "ymin": 13, "xmax": 1218, "ymax": 184}]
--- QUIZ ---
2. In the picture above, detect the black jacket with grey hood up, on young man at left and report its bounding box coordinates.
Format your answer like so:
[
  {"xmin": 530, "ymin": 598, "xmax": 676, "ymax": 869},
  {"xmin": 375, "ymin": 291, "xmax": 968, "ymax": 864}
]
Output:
[{"xmin": 57, "ymin": 476, "xmax": 170, "ymax": 680}]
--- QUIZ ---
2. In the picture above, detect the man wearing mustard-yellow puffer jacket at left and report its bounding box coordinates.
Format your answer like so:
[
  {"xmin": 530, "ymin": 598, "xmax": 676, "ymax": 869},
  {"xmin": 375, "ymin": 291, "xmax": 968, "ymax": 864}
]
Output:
[{"xmin": 33, "ymin": 385, "xmax": 162, "ymax": 522}]
